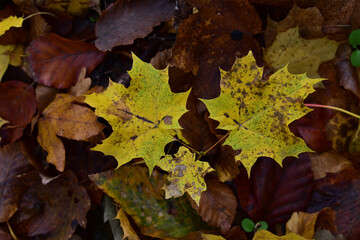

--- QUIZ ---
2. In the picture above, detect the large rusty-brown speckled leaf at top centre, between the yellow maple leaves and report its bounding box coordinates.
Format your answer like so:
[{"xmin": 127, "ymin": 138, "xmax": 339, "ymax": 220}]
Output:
[{"xmin": 170, "ymin": 0, "xmax": 262, "ymax": 98}]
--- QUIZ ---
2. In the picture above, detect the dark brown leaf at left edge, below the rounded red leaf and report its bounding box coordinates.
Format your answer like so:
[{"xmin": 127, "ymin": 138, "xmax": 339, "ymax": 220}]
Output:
[{"xmin": 0, "ymin": 143, "xmax": 33, "ymax": 222}]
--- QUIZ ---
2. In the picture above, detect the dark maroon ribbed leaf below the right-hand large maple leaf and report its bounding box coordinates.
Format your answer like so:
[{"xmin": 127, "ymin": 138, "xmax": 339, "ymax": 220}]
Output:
[{"xmin": 236, "ymin": 156, "xmax": 313, "ymax": 226}]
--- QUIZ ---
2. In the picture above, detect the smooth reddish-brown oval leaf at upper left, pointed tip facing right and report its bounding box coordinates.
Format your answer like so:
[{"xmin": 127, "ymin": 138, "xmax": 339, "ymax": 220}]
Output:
[{"xmin": 27, "ymin": 34, "xmax": 105, "ymax": 89}]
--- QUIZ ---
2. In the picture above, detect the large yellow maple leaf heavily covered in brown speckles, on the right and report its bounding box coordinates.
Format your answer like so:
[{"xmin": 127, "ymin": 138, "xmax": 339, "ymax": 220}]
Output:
[{"xmin": 203, "ymin": 52, "xmax": 323, "ymax": 172}]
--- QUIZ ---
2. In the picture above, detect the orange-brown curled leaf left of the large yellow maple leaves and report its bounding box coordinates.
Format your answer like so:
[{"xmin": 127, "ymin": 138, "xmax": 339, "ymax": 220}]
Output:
[{"xmin": 38, "ymin": 94, "xmax": 104, "ymax": 172}]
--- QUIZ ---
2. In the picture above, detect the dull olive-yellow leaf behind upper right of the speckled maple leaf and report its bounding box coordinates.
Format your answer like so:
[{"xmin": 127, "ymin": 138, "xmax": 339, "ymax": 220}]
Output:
[{"xmin": 264, "ymin": 27, "xmax": 340, "ymax": 78}]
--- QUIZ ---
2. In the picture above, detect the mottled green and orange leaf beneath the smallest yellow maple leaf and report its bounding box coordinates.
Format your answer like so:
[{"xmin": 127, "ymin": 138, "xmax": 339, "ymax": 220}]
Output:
[{"xmin": 90, "ymin": 166, "xmax": 205, "ymax": 239}]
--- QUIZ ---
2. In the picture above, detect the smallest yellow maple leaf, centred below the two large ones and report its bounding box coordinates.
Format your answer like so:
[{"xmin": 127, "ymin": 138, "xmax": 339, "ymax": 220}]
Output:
[{"xmin": 158, "ymin": 147, "xmax": 214, "ymax": 206}]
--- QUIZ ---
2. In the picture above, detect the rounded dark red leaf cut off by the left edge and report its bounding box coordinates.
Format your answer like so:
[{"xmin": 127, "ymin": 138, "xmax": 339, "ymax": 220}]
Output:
[{"xmin": 0, "ymin": 81, "xmax": 36, "ymax": 145}]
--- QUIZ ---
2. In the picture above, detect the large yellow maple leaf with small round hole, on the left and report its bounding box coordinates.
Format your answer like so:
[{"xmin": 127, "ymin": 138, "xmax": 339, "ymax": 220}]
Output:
[{"xmin": 85, "ymin": 54, "xmax": 189, "ymax": 173}]
